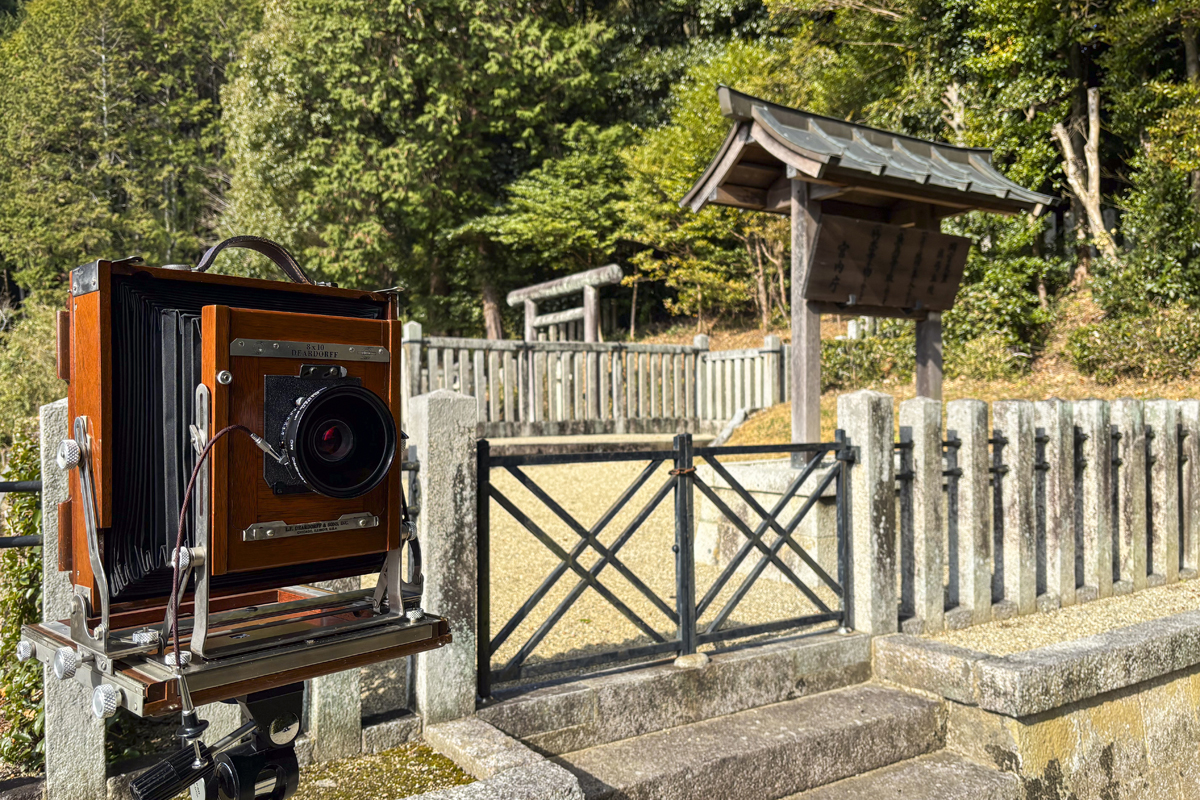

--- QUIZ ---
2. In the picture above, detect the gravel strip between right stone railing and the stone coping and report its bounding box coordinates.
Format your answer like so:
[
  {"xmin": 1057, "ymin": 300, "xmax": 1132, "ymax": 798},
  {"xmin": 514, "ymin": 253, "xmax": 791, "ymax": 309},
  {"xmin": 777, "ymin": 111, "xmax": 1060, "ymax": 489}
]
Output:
[{"xmin": 930, "ymin": 579, "xmax": 1200, "ymax": 656}]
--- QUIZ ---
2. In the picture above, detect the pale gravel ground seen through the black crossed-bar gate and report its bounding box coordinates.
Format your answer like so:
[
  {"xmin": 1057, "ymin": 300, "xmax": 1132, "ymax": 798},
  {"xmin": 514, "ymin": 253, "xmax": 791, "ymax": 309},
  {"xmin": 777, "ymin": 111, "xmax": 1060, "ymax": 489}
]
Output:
[{"xmin": 491, "ymin": 462, "xmax": 830, "ymax": 681}]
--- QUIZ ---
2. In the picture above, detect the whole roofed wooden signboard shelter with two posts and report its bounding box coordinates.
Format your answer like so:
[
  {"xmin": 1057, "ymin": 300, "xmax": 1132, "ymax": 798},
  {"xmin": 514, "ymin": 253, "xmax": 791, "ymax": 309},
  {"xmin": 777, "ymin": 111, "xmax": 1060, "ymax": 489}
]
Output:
[{"xmin": 680, "ymin": 86, "xmax": 1056, "ymax": 443}]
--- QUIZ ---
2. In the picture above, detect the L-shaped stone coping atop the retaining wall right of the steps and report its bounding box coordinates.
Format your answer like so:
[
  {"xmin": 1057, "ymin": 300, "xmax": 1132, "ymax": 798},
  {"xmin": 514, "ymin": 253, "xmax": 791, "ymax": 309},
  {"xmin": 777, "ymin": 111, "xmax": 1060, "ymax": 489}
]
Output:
[{"xmin": 872, "ymin": 610, "xmax": 1200, "ymax": 717}]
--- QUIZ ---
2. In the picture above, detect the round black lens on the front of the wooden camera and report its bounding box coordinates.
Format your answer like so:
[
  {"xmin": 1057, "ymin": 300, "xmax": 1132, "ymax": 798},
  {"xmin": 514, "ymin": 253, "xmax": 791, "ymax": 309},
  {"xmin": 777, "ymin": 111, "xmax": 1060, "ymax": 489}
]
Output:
[{"xmin": 283, "ymin": 385, "xmax": 396, "ymax": 498}]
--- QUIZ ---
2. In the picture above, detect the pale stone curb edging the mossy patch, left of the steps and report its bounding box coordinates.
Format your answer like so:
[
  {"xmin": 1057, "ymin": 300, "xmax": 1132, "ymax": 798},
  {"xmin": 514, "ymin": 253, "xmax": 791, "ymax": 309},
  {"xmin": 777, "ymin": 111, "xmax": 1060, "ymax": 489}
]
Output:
[{"xmin": 416, "ymin": 717, "xmax": 583, "ymax": 800}]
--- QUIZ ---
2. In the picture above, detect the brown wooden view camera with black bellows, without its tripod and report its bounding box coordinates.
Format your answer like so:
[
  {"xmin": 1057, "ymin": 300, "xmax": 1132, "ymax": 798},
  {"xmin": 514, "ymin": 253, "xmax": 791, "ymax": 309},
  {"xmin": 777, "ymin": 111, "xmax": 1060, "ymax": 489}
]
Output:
[{"xmin": 22, "ymin": 236, "xmax": 450, "ymax": 746}]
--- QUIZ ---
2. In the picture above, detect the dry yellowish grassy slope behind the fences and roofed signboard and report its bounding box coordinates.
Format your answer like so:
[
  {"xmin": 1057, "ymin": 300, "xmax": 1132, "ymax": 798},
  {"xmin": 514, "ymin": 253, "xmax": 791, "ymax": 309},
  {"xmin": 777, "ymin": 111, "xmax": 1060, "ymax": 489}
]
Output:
[{"xmin": 646, "ymin": 291, "xmax": 1200, "ymax": 445}]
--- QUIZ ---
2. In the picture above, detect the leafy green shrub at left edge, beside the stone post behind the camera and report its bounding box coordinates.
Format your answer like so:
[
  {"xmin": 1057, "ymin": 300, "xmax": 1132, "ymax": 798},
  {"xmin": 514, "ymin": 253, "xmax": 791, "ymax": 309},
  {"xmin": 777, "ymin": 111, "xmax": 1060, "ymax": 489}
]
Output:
[{"xmin": 0, "ymin": 429, "xmax": 44, "ymax": 771}]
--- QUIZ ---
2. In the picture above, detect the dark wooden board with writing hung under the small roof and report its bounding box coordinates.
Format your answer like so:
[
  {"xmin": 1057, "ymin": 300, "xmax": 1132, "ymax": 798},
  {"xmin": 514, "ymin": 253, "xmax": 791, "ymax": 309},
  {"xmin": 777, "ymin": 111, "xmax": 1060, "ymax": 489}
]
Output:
[{"xmin": 804, "ymin": 215, "xmax": 971, "ymax": 318}]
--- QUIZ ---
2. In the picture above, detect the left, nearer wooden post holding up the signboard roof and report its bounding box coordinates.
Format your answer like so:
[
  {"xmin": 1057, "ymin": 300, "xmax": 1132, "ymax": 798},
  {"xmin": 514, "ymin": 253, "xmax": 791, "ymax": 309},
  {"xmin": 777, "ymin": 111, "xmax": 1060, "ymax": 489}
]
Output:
[{"xmin": 792, "ymin": 180, "xmax": 821, "ymax": 467}]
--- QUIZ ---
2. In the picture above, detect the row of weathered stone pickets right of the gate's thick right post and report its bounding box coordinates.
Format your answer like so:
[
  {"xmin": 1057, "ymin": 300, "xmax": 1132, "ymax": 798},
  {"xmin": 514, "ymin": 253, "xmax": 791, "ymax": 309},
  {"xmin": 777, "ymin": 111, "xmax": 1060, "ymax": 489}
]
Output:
[{"xmin": 893, "ymin": 398, "xmax": 1200, "ymax": 632}]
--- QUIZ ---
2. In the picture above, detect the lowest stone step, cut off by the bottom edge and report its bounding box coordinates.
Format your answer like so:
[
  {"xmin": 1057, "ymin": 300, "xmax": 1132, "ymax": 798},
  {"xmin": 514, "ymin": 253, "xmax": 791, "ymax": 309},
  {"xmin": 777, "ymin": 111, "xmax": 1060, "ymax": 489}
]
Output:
[{"xmin": 787, "ymin": 750, "xmax": 1021, "ymax": 800}]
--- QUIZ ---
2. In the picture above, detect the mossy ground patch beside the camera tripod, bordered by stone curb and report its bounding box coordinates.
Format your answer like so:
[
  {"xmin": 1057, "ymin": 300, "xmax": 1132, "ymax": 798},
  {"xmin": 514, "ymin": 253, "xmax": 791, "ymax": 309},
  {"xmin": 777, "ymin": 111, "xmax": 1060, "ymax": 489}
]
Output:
[{"xmin": 292, "ymin": 744, "xmax": 475, "ymax": 800}]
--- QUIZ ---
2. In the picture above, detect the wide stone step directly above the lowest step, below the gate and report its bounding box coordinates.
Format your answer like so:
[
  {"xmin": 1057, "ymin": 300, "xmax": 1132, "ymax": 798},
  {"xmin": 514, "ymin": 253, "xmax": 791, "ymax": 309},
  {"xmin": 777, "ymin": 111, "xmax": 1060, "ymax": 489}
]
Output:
[{"xmin": 556, "ymin": 684, "xmax": 946, "ymax": 800}]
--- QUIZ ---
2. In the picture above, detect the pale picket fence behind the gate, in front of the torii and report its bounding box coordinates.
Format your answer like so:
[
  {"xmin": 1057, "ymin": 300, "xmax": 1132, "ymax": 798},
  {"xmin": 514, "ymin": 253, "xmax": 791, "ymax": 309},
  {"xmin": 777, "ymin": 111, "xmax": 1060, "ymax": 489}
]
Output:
[{"xmin": 401, "ymin": 323, "xmax": 787, "ymax": 438}]
